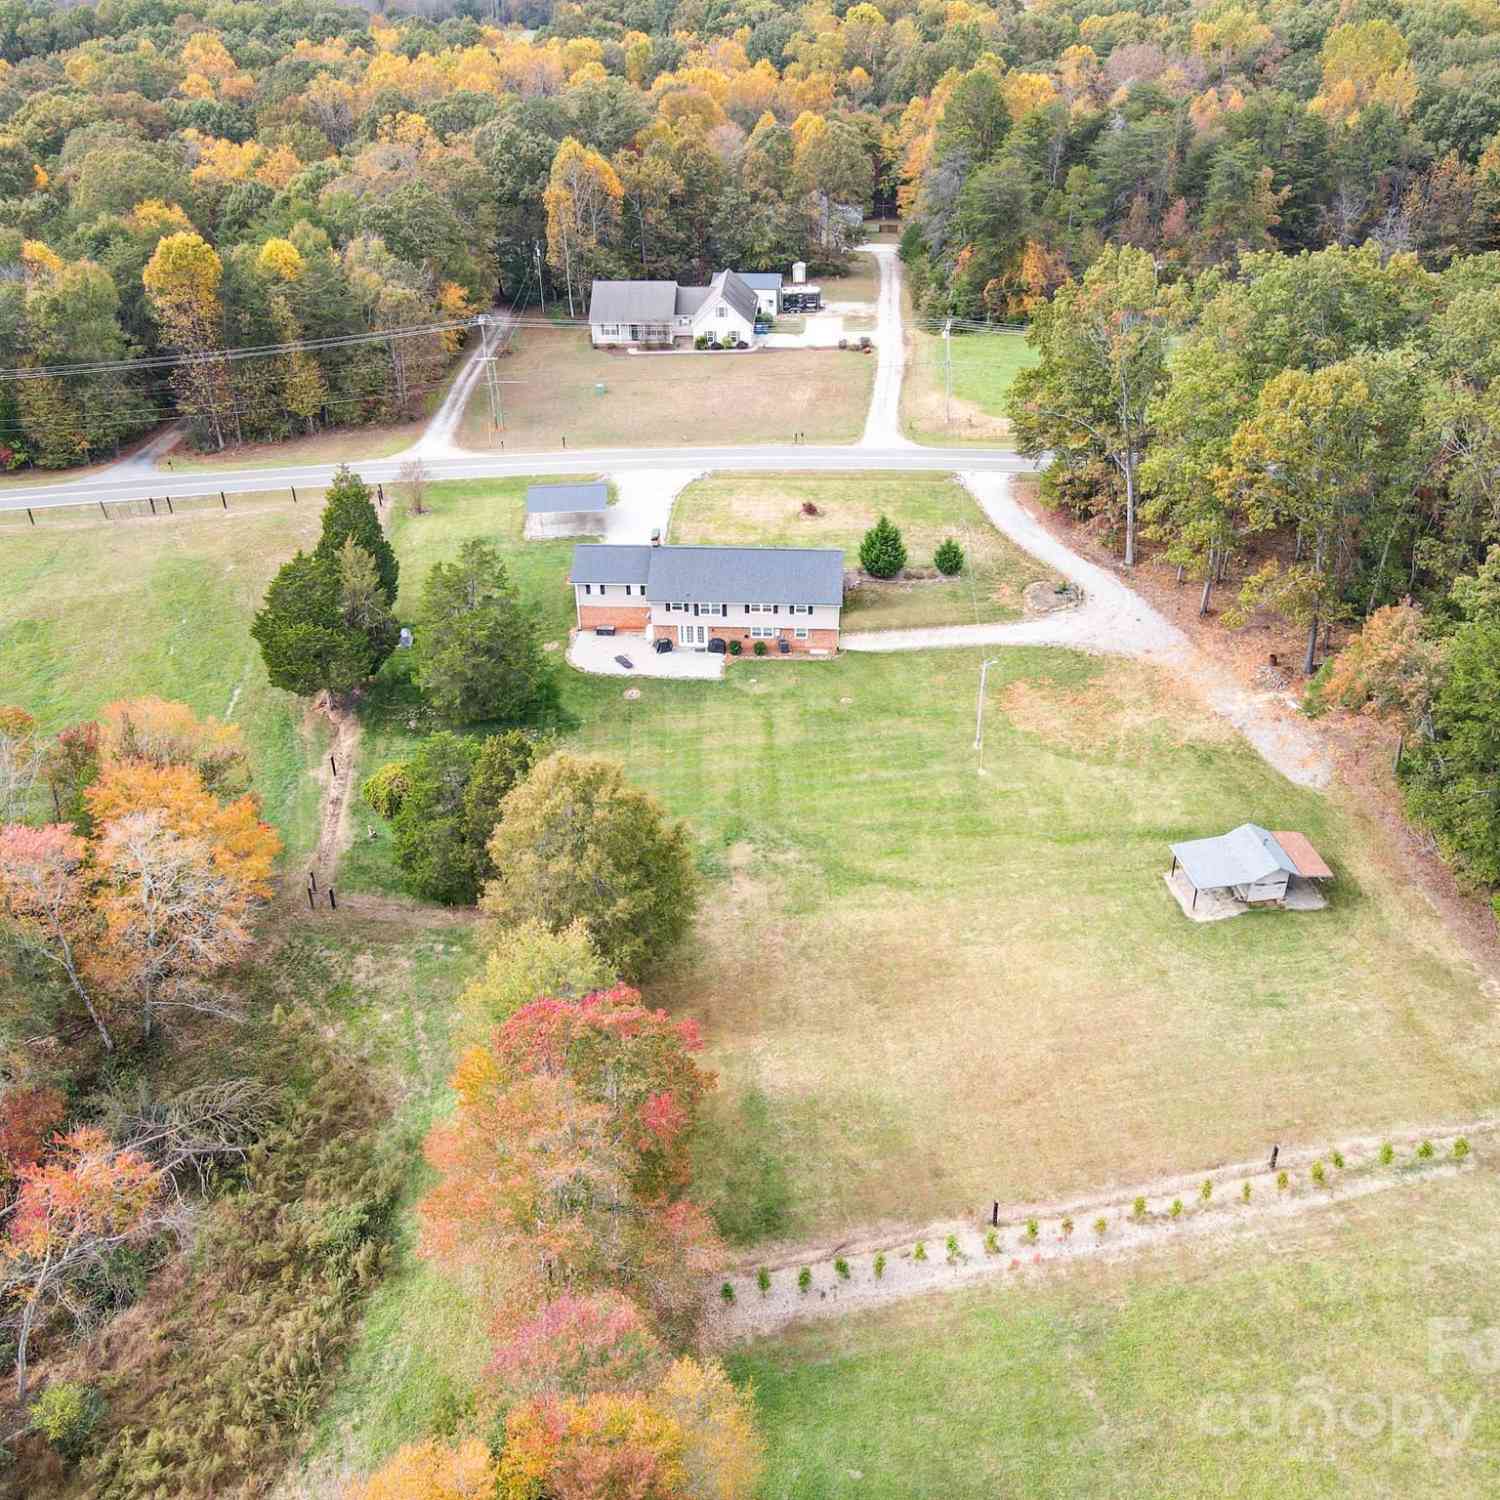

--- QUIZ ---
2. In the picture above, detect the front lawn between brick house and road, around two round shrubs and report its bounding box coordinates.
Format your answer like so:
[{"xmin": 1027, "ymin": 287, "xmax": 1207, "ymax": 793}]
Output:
[{"xmin": 671, "ymin": 474, "xmax": 1047, "ymax": 630}]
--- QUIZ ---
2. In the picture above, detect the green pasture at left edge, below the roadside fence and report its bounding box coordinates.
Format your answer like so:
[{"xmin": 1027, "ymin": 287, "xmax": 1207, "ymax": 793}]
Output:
[{"xmin": 0, "ymin": 492, "xmax": 324, "ymax": 854}]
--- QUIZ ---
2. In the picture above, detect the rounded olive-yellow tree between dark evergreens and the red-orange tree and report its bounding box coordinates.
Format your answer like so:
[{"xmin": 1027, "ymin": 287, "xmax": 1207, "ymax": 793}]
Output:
[{"xmin": 480, "ymin": 753, "xmax": 699, "ymax": 978}]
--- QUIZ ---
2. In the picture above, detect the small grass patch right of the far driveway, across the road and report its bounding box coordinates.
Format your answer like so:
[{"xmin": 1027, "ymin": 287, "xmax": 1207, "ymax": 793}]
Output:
[{"xmin": 902, "ymin": 322, "xmax": 1037, "ymax": 446}]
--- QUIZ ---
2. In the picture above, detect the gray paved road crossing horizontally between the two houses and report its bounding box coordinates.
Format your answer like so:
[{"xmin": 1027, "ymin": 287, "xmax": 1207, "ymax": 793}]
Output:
[{"xmin": 0, "ymin": 444, "xmax": 1037, "ymax": 510}]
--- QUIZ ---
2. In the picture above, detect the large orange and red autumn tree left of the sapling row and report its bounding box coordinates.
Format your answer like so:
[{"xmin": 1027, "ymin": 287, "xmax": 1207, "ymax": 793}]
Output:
[{"xmin": 422, "ymin": 986, "xmax": 719, "ymax": 1340}]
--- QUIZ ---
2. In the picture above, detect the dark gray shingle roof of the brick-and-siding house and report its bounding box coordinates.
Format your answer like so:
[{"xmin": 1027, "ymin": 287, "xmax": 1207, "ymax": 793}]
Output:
[{"xmin": 572, "ymin": 542, "xmax": 843, "ymax": 605}]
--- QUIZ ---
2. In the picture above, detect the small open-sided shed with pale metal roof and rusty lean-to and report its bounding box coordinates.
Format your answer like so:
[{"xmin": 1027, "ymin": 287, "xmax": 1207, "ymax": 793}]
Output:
[{"xmin": 1166, "ymin": 824, "xmax": 1334, "ymax": 921}]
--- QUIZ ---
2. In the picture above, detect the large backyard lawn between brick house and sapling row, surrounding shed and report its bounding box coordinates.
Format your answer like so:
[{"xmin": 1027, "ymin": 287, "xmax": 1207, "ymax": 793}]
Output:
[{"xmin": 569, "ymin": 650, "xmax": 1497, "ymax": 1242}]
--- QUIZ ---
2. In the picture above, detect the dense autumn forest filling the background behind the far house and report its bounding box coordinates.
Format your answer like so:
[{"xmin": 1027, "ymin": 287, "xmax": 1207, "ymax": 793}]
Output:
[{"xmin": 0, "ymin": 0, "xmax": 1500, "ymax": 467}]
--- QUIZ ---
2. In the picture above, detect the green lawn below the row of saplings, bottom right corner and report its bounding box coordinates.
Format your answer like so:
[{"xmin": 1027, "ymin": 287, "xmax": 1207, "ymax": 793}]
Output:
[{"xmin": 731, "ymin": 1164, "xmax": 1500, "ymax": 1500}]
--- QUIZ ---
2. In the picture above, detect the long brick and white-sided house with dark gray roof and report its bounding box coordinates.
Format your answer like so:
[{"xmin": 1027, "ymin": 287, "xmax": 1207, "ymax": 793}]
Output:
[{"xmin": 569, "ymin": 542, "xmax": 843, "ymax": 656}]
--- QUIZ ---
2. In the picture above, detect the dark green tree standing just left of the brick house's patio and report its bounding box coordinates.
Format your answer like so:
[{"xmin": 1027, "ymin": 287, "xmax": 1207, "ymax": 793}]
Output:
[{"xmin": 413, "ymin": 540, "xmax": 558, "ymax": 725}]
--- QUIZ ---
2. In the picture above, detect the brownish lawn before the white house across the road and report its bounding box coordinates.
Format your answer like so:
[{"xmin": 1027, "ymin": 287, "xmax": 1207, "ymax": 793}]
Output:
[{"xmin": 461, "ymin": 329, "xmax": 875, "ymax": 452}]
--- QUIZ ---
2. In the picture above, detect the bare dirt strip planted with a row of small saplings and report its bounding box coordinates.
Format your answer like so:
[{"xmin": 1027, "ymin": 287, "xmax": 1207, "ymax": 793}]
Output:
[{"xmin": 704, "ymin": 1116, "xmax": 1500, "ymax": 1346}]
